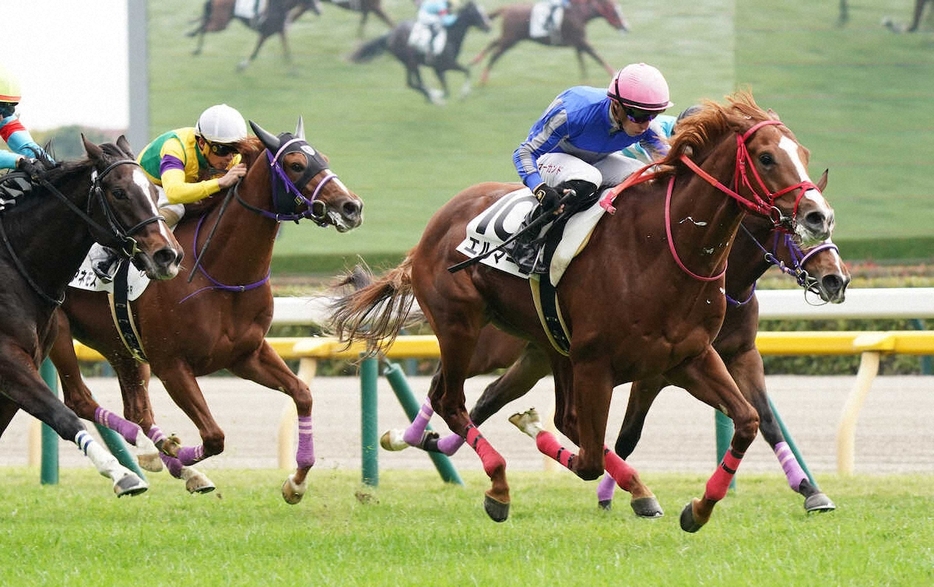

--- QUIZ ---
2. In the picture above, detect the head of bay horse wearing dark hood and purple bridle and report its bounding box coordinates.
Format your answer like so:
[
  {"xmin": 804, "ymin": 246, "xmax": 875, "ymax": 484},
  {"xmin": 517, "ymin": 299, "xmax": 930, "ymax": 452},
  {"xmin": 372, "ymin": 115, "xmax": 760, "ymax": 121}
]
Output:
[{"xmin": 250, "ymin": 118, "xmax": 363, "ymax": 232}]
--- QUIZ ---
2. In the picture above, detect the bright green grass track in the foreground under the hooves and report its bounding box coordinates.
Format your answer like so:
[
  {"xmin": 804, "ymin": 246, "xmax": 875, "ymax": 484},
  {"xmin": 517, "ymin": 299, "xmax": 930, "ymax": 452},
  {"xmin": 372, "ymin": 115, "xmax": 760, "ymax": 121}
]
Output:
[{"xmin": 0, "ymin": 468, "xmax": 934, "ymax": 587}]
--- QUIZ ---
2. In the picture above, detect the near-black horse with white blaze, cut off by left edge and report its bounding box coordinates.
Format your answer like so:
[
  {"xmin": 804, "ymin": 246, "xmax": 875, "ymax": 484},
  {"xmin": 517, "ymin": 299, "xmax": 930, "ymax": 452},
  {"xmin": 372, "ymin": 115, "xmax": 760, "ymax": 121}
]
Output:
[{"xmin": 0, "ymin": 136, "xmax": 181, "ymax": 496}]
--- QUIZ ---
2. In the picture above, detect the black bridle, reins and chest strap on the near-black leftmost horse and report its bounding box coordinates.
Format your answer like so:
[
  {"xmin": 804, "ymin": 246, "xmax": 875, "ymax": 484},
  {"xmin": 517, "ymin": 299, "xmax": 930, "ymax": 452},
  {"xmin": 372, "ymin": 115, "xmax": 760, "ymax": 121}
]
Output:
[{"xmin": 0, "ymin": 159, "xmax": 165, "ymax": 306}]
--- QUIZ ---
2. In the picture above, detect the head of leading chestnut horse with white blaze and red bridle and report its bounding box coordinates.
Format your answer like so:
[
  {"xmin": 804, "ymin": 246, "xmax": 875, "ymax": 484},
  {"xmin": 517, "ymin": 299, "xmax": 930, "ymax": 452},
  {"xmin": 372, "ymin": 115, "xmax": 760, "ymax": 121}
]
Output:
[{"xmin": 665, "ymin": 92, "xmax": 834, "ymax": 247}]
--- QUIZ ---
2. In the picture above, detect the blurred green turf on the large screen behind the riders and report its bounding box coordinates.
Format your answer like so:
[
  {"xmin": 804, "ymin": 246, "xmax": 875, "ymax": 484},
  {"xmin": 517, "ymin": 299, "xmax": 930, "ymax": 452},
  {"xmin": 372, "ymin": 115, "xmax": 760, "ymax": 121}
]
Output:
[{"xmin": 148, "ymin": 0, "xmax": 934, "ymax": 273}]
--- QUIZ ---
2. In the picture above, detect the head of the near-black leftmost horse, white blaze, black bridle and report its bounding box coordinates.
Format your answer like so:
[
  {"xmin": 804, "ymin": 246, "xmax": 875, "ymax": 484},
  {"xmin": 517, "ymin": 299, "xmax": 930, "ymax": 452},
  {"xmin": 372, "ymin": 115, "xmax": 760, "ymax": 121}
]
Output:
[{"xmin": 81, "ymin": 134, "xmax": 182, "ymax": 280}]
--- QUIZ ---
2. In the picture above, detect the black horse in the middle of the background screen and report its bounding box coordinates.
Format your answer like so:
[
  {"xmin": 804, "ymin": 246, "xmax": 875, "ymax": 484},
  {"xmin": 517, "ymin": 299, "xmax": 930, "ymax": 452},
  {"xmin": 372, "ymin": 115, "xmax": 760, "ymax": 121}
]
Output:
[{"xmin": 350, "ymin": 0, "xmax": 498, "ymax": 103}]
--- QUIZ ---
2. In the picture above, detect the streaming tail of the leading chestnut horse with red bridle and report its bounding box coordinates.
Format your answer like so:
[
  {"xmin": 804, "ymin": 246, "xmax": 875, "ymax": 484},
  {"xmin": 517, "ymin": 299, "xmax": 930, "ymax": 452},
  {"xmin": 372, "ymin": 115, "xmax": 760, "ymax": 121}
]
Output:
[{"xmin": 329, "ymin": 256, "xmax": 415, "ymax": 350}]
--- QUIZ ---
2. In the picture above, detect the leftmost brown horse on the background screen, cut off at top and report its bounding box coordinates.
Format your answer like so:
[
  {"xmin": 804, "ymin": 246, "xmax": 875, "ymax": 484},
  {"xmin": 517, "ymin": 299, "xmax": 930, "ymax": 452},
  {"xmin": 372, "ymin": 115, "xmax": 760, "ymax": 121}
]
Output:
[{"xmin": 188, "ymin": 0, "xmax": 321, "ymax": 69}]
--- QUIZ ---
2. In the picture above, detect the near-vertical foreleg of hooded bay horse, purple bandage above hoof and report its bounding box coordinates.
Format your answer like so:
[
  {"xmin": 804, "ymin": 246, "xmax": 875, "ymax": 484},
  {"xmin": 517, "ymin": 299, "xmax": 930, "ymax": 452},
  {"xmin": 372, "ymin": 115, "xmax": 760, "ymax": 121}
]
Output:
[{"xmin": 230, "ymin": 341, "xmax": 315, "ymax": 504}]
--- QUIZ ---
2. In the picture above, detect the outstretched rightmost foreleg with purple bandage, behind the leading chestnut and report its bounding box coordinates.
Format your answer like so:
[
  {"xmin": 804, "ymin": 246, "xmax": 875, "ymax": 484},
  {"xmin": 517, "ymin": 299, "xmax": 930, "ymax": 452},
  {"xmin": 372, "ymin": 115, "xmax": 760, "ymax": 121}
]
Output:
[{"xmin": 727, "ymin": 348, "xmax": 836, "ymax": 512}]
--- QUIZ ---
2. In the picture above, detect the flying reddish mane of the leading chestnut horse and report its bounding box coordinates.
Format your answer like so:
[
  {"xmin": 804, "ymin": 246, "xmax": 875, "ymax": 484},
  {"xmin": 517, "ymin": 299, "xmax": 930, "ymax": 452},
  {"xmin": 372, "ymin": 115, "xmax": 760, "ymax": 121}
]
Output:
[{"xmin": 659, "ymin": 90, "xmax": 791, "ymax": 176}]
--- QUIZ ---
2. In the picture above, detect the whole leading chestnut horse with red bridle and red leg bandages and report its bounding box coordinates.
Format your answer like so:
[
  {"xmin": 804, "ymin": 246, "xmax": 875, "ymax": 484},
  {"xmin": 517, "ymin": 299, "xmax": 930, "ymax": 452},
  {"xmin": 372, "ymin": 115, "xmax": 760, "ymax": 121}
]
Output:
[{"xmin": 333, "ymin": 92, "xmax": 833, "ymax": 532}]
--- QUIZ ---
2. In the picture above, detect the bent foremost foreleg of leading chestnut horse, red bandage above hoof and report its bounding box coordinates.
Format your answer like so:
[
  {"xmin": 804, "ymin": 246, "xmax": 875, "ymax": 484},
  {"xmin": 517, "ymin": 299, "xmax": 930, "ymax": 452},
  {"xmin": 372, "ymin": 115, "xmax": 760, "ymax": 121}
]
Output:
[{"xmin": 667, "ymin": 347, "xmax": 759, "ymax": 532}]
